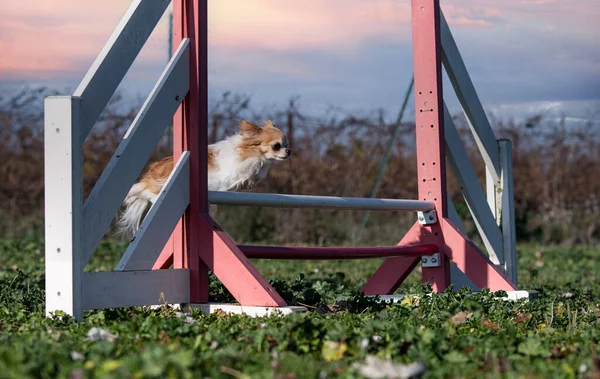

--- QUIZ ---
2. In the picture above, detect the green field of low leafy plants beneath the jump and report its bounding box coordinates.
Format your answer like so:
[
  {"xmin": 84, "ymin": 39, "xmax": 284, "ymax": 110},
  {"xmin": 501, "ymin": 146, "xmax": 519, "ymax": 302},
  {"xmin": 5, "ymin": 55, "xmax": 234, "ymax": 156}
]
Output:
[{"xmin": 0, "ymin": 237, "xmax": 600, "ymax": 378}]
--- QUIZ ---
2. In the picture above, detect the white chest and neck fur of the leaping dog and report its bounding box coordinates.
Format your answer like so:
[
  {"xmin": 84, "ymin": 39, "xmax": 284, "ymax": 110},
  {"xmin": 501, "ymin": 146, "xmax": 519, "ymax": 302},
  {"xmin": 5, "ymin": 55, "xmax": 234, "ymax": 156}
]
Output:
[{"xmin": 208, "ymin": 135, "xmax": 271, "ymax": 191}]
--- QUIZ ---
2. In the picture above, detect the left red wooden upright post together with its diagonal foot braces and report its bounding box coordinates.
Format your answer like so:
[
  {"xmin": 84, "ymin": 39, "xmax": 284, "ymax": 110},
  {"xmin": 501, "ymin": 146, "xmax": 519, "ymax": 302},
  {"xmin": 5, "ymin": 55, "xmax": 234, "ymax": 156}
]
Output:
[{"xmin": 155, "ymin": 0, "xmax": 285, "ymax": 306}]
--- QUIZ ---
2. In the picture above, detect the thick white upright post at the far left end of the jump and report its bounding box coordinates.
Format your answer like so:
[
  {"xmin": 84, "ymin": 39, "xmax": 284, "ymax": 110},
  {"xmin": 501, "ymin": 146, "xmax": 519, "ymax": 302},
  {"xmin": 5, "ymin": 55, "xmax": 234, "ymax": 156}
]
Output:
[{"xmin": 44, "ymin": 96, "xmax": 83, "ymax": 320}]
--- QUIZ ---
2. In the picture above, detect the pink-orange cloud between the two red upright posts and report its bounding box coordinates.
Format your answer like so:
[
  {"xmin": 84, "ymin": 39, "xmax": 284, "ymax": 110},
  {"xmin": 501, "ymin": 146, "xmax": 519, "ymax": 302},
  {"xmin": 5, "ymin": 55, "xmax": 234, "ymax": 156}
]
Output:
[{"xmin": 209, "ymin": 0, "xmax": 410, "ymax": 50}]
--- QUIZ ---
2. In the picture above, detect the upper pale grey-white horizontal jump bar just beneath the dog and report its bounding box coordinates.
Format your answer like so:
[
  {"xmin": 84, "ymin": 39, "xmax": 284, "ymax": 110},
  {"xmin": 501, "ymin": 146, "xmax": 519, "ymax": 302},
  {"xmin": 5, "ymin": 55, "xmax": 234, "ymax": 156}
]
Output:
[{"xmin": 208, "ymin": 191, "xmax": 435, "ymax": 212}]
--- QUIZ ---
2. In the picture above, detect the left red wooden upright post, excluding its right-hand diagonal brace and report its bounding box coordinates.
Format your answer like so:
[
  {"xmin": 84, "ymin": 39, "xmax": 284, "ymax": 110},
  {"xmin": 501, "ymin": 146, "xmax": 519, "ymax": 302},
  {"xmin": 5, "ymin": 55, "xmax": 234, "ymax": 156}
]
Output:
[{"xmin": 154, "ymin": 0, "xmax": 208, "ymax": 303}]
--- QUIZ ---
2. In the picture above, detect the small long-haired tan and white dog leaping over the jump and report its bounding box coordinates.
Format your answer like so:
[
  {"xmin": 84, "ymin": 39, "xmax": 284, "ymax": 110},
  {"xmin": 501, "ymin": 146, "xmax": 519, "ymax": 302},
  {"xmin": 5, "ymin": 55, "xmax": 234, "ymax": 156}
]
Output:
[{"xmin": 116, "ymin": 120, "xmax": 291, "ymax": 236}]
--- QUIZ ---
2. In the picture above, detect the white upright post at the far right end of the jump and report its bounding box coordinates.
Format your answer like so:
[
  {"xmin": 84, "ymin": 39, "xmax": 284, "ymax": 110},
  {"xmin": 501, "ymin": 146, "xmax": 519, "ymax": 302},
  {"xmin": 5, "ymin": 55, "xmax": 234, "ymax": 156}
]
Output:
[{"xmin": 498, "ymin": 139, "xmax": 518, "ymax": 286}]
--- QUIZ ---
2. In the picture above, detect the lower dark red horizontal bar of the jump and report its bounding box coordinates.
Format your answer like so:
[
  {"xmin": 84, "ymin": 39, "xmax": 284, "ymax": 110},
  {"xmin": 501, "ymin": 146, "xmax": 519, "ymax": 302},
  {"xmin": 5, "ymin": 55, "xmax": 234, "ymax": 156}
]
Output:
[{"xmin": 238, "ymin": 244, "xmax": 438, "ymax": 260}]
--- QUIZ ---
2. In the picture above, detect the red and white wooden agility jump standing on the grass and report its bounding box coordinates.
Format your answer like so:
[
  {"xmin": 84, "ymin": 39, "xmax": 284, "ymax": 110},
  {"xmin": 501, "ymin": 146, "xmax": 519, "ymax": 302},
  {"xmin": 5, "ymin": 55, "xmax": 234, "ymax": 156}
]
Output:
[{"xmin": 45, "ymin": 0, "xmax": 517, "ymax": 320}]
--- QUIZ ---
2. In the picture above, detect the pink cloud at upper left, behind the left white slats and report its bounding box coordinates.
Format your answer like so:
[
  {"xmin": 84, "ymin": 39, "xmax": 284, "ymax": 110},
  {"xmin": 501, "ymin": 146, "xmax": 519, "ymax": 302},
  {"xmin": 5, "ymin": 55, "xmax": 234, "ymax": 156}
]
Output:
[{"xmin": 0, "ymin": 0, "xmax": 171, "ymax": 79}]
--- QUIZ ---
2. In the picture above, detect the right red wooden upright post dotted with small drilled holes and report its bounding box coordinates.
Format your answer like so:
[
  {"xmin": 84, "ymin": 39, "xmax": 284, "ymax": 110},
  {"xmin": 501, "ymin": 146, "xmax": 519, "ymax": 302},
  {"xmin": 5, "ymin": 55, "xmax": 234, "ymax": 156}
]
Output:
[{"xmin": 412, "ymin": 0, "xmax": 450, "ymax": 292}]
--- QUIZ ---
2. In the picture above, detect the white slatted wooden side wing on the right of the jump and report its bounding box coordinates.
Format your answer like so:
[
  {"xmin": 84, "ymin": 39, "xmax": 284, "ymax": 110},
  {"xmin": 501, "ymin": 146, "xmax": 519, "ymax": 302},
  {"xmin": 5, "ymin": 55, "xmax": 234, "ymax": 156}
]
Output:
[{"xmin": 440, "ymin": 11, "xmax": 517, "ymax": 285}]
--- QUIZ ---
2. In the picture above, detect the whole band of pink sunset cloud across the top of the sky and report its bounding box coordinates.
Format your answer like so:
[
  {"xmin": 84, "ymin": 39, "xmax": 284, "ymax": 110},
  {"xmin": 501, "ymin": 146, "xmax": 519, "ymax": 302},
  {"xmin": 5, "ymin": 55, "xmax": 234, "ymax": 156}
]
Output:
[{"xmin": 0, "ymin": 0, "xmax": 600, "ymax": 79}]
